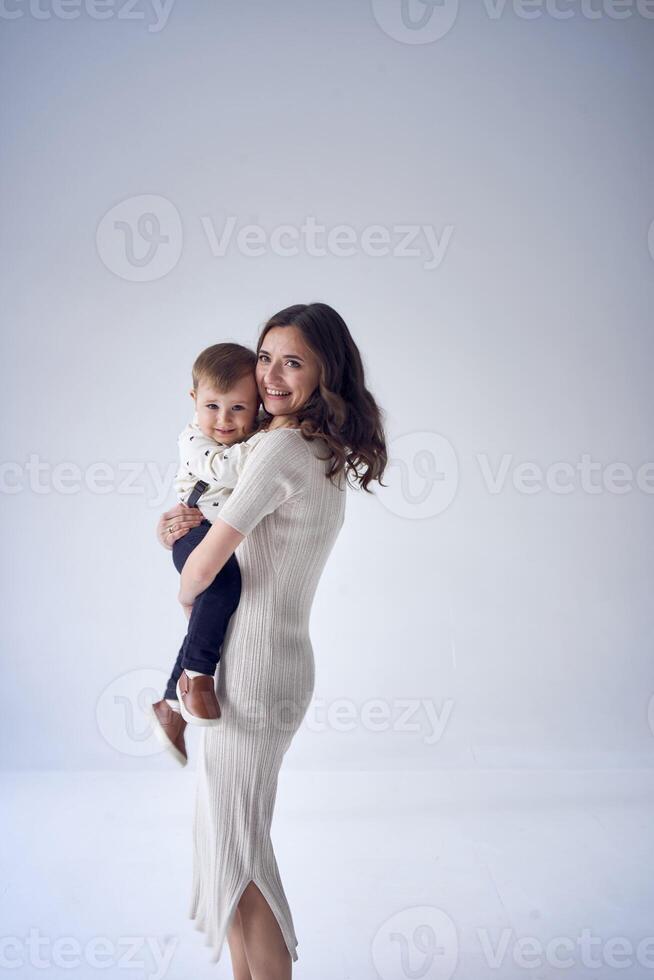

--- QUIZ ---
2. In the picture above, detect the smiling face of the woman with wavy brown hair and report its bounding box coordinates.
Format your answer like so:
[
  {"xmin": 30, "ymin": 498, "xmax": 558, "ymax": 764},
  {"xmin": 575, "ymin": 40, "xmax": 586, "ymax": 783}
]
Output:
[{"xmin": 256, "ymin": 326, "xmax": 320, "ymax": 416}]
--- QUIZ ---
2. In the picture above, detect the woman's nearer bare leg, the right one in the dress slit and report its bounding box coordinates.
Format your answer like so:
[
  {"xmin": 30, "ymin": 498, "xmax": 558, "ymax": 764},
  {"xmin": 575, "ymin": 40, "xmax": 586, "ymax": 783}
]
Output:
[{"xmin": 238, "ymin": 881, "xmax": 293, "ymax": 980}]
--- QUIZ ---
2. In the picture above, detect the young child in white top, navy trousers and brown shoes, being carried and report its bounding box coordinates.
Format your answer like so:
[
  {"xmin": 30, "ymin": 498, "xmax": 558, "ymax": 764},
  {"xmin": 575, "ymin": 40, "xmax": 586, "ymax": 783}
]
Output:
[{"xmin": 151, "ymin": 343, "xmax": 266, "ymax": 765}]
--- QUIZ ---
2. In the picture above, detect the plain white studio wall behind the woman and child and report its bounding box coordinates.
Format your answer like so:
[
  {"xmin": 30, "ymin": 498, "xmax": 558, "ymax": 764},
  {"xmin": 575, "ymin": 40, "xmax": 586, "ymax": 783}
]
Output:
[{"xmin": 0, "ymin": 0, "xmax": 654, "ymax": 770}]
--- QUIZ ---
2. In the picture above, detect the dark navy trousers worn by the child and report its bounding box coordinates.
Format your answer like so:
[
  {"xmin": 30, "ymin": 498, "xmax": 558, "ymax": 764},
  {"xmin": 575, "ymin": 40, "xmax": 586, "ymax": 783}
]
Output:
[{"xmin": 164, "ymin": 518, "xmax": 241, "ymax": 699}]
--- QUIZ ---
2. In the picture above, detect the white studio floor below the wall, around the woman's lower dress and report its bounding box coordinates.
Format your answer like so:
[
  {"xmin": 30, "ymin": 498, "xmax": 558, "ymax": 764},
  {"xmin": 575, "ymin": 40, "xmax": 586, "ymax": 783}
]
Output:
[{"xmin": 5, "ymin": 762, "xmax": 654, "ymax": 980}]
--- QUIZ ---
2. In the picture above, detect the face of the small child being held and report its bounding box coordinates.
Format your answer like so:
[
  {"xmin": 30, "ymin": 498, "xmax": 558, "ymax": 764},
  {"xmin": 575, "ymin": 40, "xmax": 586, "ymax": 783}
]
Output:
[{"xmin": 191, "ymin": 373, "xmax": 259, "ymax": 446}]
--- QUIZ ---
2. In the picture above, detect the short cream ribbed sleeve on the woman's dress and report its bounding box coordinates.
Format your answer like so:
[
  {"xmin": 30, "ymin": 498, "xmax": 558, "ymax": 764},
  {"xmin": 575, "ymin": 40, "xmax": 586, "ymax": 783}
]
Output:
[{"xmin": 220, "ymin": 428, "xmax": 311, "ymax": 534}]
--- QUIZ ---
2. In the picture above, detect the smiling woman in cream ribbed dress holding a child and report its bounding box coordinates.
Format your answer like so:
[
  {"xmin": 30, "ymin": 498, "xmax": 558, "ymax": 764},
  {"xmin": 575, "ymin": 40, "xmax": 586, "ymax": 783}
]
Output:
[{"xmin": 159, "ymin": 303, "xmax": 386, "ymax": 980}]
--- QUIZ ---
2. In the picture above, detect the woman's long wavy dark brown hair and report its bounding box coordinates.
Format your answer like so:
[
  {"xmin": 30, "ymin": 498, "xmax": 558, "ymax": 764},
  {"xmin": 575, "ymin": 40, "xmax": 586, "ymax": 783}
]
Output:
[{"xmin": 257, "ymin": 303, "xmax": 388, "ymax": 493}]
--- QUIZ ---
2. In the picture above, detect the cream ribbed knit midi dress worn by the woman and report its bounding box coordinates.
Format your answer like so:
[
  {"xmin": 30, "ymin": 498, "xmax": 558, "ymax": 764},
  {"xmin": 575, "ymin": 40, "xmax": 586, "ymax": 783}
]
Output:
[{"xmin": 190, "ymin": 428, "xmax": 346, "ymax": 962}]
